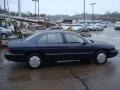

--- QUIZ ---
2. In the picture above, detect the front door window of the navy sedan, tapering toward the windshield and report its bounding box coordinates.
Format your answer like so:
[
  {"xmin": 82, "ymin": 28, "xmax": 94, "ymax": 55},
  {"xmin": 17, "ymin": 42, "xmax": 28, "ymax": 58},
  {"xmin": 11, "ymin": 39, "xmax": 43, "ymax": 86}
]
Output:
[{"xmin": 65, "ymin": 33, "xmax": 84, "ymax": 43}]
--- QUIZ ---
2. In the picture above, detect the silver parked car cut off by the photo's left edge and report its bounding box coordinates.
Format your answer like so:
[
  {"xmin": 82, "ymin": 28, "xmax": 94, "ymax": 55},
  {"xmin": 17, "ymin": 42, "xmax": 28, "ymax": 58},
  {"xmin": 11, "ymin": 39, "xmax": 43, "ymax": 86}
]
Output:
[{"xmin": 0, "ymin": 27, "xmax": 12, "ymax": 39}]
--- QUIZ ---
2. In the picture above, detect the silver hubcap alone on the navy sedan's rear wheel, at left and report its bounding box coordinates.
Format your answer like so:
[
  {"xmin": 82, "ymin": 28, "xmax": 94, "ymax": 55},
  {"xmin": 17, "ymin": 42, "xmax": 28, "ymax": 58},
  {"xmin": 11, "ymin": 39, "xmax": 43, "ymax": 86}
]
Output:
[{"xmin": 29, "ymin": 56, "xmax": 41, "ymax": 68}]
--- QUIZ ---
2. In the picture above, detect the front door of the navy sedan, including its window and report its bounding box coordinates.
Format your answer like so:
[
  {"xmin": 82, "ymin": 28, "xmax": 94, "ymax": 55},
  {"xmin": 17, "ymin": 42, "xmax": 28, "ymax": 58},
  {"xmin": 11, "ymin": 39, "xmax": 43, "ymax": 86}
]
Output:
[{"xmin": 64, "ymin": 33, "xmax": 93, "ymax": 60}]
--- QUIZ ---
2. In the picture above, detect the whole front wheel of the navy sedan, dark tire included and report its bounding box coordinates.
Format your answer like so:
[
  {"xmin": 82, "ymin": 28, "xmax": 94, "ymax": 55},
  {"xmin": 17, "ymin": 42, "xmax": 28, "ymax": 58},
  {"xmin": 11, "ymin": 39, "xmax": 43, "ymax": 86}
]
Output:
[{"xmin": 95, "ymin": 50, "xmax": 107, "ymax": 64}]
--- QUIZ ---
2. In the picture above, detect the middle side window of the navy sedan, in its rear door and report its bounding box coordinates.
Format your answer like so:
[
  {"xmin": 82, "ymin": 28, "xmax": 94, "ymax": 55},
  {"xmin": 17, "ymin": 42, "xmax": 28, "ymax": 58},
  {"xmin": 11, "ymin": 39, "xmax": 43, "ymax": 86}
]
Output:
[{"xmin": 47, "ymin": 33, "xmax": 63, "ymax": 44}]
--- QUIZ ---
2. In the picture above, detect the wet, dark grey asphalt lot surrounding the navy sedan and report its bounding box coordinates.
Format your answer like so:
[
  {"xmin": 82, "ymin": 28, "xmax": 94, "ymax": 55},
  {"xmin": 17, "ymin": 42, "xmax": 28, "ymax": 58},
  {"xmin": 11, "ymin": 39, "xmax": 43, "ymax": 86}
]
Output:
[{"xmin": 0, "ymin": 27, "xmax": 120, "ymax": 90}]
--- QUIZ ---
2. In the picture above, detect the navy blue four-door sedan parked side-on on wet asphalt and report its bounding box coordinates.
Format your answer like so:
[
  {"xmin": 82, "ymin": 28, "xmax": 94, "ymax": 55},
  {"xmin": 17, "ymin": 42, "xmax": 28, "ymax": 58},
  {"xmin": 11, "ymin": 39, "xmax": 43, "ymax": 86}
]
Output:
[{"xmin": 4, "ymin": 30, "xmax": 118, "ymax": 69}]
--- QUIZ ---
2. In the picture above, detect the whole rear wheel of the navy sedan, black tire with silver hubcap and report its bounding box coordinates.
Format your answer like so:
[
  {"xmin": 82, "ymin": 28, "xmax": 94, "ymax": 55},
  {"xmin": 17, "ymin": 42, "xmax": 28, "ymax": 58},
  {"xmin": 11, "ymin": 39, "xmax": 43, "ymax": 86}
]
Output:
[{"xmin": 27, "ymin": 53, "xmax": 42, "ymax": 69}]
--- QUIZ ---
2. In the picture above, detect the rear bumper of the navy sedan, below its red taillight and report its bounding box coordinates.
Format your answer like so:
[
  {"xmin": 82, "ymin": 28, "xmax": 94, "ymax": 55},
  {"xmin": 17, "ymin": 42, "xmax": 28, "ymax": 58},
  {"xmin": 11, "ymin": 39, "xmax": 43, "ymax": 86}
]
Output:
[{"xmin": 4, "ymin": 51, "xmax": 26, "ymax": 62}]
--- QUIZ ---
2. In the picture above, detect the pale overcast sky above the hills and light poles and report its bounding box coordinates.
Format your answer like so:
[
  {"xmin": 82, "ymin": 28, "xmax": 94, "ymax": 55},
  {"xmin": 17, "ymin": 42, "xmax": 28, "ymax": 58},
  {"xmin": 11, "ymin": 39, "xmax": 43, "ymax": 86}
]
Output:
[{"xmin": 0, "ymin": 0, "xmax": 120, "ymax": 15}]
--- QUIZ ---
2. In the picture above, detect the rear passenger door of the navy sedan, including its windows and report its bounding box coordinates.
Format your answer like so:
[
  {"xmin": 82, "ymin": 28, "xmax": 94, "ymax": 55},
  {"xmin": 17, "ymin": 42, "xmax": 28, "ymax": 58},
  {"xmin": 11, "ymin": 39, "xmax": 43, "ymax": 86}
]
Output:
[{"xmin": 39, "ymin": 32, "xmax": 67, "ymax": 61}]
